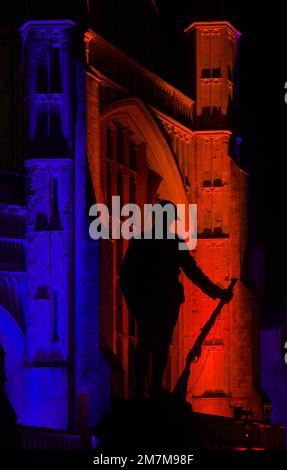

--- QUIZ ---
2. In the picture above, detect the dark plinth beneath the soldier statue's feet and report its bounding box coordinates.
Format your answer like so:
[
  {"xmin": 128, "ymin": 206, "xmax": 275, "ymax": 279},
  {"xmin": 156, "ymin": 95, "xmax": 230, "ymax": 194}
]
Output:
[{"xmin": 95, "ymin": 394, "xmax": 207, "ymax": 452}]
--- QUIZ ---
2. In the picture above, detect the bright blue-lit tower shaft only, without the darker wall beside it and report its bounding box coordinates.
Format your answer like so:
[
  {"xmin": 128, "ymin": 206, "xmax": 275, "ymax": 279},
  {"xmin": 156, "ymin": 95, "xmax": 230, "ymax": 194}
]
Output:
[{"xmin": 21, "ymin": 21, "xmax": 73, "ymax": 428}]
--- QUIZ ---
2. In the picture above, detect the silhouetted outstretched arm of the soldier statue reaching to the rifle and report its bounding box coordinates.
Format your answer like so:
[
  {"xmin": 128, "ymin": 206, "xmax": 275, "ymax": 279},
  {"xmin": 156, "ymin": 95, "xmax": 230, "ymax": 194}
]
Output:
[{"xmin": 179, "ymin": 250, "xmax": 225, "ymax": 299}]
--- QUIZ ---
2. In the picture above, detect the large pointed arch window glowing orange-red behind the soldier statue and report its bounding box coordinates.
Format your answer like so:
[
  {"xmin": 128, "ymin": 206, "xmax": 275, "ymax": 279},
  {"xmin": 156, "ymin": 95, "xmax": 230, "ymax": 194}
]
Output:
[{"xmin": 100, "ymin": 98, "xmax": 188, "ymax": 397}]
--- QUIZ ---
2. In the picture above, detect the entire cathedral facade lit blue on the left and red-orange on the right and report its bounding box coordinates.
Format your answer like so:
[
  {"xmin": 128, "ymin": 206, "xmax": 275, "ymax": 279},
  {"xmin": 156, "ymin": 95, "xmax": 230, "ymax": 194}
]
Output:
[{"xmin": 0, "ymin": 16, "xmax": 264, "ymax": 430}]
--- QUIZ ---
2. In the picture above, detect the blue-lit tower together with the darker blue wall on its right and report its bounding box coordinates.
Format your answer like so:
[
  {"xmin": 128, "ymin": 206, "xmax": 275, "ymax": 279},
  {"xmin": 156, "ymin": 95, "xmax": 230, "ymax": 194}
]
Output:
[{"xmin": 17, "ymin": 21, "xmax": 109, "ymax": 430}]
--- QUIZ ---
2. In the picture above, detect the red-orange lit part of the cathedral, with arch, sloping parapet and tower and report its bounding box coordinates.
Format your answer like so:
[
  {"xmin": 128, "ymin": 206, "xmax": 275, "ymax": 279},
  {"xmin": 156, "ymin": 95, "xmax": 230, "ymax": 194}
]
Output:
[{"xmin": 85, "ymin": 22, "xmax": 264, "ymax": 419}]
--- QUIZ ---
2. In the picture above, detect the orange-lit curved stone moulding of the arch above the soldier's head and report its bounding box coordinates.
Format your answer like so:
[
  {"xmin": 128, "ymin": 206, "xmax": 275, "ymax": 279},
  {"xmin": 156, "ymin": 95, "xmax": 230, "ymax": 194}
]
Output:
[{"xmin": 101, "ymin": 98, "xmax": 188, "ymax": 204}]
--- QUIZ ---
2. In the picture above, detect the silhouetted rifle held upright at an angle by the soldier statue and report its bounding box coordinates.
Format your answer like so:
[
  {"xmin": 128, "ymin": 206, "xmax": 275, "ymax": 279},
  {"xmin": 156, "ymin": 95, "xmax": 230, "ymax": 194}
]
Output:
[{"xmin": 172, "ymin": 279, "xmax": 237, "ymax": 401}]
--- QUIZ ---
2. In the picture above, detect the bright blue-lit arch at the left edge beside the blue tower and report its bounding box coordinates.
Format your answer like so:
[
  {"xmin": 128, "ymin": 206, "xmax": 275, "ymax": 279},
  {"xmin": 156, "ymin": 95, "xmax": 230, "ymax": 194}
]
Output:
[{"xmin": 0, "ymin": 305, "xmax": 26, "ymax": 421}]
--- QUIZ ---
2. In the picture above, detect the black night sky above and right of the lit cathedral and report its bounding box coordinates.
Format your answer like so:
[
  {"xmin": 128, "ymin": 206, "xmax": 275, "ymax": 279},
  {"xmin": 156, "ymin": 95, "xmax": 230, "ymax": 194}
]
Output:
[{"xmin": 1, "ymin": 0, "xmax": 287, "ymax": 306}]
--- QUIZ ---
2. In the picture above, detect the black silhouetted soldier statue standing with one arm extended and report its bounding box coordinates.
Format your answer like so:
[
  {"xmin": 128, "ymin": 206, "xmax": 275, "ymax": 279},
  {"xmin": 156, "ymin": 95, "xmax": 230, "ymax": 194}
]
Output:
[{"xmin": 120, "ymin": 201, "xmax": 232, "ymax": 398}]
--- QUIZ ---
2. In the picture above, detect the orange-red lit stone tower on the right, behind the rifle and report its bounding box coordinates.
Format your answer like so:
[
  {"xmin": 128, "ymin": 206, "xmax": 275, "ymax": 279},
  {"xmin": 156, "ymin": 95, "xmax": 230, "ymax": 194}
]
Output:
[{"xmin": 186, "ymin": 21, "xmax": 263, "ymax": 418}]
